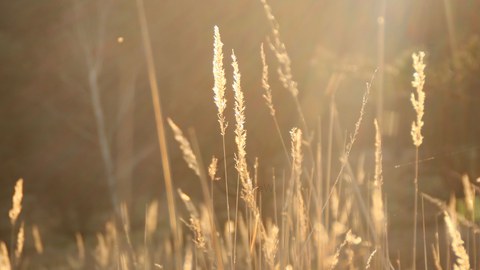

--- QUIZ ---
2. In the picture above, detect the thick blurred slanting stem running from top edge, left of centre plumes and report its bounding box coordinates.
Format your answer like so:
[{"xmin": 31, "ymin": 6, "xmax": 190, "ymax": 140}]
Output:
[{"xmin": 137, "ymin": 0, "xmax": 182, "ymax": 269}]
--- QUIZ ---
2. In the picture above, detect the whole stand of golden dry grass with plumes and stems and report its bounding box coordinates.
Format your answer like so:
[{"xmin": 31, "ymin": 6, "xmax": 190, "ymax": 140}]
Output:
[{"xmin": 0, "ymin": 0, "xmax": 480, "ymax": 270}]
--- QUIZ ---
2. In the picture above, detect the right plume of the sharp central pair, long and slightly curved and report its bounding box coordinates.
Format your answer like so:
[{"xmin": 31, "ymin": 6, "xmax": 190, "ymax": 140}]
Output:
[{"xmin": 232, "ymin": 50, "xmax": 259, "ymax": 211}]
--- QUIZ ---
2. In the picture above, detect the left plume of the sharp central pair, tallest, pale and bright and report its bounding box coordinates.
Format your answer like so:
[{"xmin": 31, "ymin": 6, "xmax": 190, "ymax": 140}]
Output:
[{"xmin": 213, "ymin": 25, "xmax": 228, "ymax": 136}]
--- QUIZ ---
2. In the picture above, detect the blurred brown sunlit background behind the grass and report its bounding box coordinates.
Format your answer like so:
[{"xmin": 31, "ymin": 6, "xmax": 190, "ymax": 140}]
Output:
[{"xmin": 0, "ymin": 0, "xmax": 480, "ymax": 266}]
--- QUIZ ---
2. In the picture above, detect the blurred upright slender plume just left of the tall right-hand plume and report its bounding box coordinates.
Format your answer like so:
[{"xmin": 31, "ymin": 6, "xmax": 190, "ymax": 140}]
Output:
[{"xmin": 371, "ymin": 119, "xmax": 385, "ymax": 238}]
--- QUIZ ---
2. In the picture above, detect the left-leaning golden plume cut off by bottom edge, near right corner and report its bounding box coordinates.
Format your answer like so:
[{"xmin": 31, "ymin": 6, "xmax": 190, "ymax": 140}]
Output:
[{"xmin": 443, "ymin": 211, "xmax": 470, "ymax": 270}]
